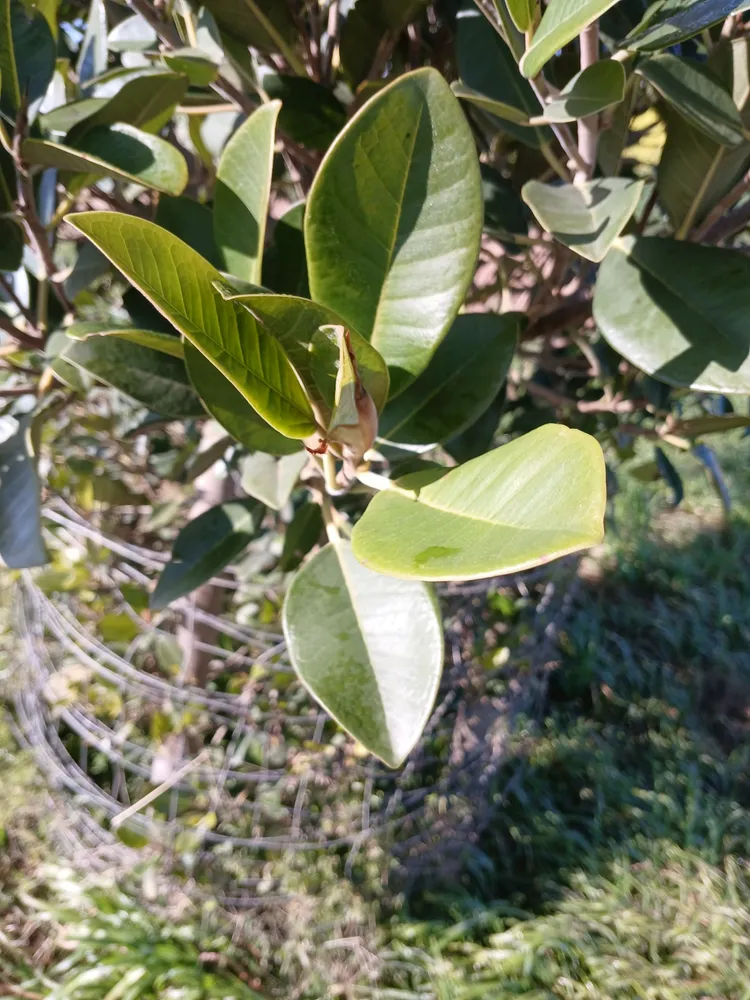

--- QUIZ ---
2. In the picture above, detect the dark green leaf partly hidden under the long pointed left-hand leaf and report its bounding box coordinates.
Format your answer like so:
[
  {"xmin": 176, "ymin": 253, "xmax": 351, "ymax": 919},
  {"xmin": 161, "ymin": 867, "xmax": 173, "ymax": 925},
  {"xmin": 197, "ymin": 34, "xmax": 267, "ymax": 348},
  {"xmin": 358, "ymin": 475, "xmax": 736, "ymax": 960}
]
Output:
[{"xmin": 184, "ymin": 341, "xmax": 299, "ymax": 455}]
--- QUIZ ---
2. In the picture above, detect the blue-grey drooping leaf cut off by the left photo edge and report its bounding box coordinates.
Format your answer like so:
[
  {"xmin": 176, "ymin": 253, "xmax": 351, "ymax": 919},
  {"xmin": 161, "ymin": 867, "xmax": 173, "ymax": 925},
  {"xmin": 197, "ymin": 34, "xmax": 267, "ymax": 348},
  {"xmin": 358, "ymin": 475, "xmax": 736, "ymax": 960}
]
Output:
[{"xmin": 0, "ymin": 414, "xmax": 47, "ymax": 569}]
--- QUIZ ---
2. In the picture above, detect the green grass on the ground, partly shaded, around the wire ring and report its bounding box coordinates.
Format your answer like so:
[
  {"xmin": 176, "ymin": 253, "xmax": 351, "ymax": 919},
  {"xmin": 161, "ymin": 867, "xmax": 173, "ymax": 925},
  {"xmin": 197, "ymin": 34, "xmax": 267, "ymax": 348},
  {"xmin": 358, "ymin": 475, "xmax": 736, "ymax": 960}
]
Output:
[{"xmin": 0, "ymin": 435, "xmax": 750, "ymax": 1000}]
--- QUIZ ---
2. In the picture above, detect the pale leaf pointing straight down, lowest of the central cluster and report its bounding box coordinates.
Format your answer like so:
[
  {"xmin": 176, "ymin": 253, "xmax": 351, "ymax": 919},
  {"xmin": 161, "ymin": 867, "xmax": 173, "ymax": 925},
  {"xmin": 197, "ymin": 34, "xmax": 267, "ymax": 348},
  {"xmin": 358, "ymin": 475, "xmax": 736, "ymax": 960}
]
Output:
[{"xmin": 284, "ymin": 541, "xmax": 443, "ymax": 767}]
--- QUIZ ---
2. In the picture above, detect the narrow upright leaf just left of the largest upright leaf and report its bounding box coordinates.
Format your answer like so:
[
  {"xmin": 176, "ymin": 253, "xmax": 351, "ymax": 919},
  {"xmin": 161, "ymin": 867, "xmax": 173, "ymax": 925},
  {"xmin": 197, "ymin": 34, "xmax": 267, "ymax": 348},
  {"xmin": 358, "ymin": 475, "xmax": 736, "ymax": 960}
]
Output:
[{"xmin": 214, "ymin": 101, "xmax": 281, "ymax": 284}]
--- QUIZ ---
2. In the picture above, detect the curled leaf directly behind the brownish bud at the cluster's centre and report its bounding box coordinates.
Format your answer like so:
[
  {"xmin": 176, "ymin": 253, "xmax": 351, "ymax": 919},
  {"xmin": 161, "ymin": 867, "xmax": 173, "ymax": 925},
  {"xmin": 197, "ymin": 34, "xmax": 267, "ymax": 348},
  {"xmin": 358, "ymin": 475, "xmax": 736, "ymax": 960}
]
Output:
[{"xmin": 220, "ymin": 293, "xmax": 389, "ymax": 422}]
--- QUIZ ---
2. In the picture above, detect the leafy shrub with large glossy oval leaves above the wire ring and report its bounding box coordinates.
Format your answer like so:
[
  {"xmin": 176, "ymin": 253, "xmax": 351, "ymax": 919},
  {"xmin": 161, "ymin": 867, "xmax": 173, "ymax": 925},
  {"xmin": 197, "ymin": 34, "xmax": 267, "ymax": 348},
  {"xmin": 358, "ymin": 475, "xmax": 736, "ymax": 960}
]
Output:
[{"xmin": 0, "ymin": 0, "xmax": 750, "ymax": 767}]
